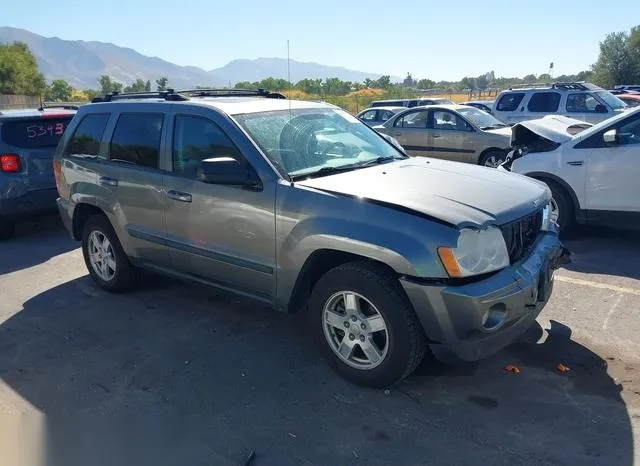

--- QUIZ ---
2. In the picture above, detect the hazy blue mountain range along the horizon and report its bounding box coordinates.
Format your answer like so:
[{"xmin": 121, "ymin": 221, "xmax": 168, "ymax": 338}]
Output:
[{"xmin": 0, "ymin": 27, "xmax": 400, "ymax": 89}]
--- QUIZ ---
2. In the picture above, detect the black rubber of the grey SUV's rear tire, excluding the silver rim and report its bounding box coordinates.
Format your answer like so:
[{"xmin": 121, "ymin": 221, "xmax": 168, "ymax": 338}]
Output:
[{"xmin": 82, "ymin": 215, "xmax": 140, "ymax": 293}]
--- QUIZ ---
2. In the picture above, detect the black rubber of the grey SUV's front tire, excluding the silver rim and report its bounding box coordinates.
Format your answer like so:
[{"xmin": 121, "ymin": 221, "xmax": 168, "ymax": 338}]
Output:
[{"xmin": 309, "ymin": 262, "xmax": 427, "ymax": 388}]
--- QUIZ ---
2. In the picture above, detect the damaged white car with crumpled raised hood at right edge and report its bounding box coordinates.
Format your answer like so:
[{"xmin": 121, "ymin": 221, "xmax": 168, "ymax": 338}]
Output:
[{"xmin": 499, "ymin": 108, "xmax": 640, "ymax": 230}]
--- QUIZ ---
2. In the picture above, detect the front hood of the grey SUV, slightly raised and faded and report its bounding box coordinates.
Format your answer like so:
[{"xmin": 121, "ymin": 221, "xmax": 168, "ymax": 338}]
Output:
[{"xmin": 296, "ymin": 157, "xmax": 550, "ymax": 228}]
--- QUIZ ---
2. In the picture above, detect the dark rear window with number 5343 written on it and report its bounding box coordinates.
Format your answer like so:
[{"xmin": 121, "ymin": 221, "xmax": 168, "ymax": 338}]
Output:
[{"xmin": 2, "ymin": 116, "xmax": 71, "ymax": 149}]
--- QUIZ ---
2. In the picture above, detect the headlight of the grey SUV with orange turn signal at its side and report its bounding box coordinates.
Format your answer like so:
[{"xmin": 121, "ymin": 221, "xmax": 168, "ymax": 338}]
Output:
[{"xmin": 438, "ymin": 227, "xmax": 509, "ymax": 277}]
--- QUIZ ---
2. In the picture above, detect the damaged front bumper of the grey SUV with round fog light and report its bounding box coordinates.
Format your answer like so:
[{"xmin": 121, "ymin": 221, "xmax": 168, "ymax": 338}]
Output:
[{"xmin": 401, "ymin": 233, "xmax": 570, "ymax": 362}]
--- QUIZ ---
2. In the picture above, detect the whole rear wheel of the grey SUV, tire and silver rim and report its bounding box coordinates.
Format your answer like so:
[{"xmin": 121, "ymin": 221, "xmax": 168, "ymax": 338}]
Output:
[{"xmin": 82, "ymin": 215, "xmax": 140, "ymax": 293}]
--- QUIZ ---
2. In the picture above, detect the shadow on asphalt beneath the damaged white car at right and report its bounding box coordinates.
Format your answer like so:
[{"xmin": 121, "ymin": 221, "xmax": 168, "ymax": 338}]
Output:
[{"xmin": 563, "ymin": 227, "xmax": 640, "ymax": 280}]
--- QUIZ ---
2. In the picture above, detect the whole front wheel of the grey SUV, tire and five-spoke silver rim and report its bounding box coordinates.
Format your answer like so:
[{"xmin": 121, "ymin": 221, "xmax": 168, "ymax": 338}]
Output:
[{"xmin": 309, "ymin": 262, "xmax": 427, "ymax": 388}]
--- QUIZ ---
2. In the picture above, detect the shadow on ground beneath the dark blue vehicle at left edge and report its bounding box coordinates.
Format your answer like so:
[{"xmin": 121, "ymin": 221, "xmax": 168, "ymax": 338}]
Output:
[{"xmin": 0, "ymin": 215, "xmax": 79, "ymax": 275}]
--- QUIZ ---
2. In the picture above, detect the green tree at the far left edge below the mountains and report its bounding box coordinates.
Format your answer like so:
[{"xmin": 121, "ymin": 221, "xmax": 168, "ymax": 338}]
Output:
[{"xmin": 0, "ymin": 42, "xmax": 46, "ymax": 95}]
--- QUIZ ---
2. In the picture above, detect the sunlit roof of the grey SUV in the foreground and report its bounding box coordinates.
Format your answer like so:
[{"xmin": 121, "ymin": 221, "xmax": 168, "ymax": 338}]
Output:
[{"xmin": 90, "ymin": 97, "xmax": 338, "ymax": 115}]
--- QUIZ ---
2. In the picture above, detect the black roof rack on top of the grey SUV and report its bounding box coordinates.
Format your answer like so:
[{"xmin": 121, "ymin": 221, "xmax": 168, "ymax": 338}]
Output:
[{"xmin": 91, "ymin": 89, "xmax": 286, "ymax": 103}]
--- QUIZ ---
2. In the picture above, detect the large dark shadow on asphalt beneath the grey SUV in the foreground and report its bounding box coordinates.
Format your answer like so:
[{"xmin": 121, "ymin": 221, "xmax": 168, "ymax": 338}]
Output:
[{"xmin": 0, "ymin": 277, "xmax": 633, "ymax": 466}]
